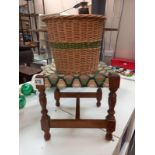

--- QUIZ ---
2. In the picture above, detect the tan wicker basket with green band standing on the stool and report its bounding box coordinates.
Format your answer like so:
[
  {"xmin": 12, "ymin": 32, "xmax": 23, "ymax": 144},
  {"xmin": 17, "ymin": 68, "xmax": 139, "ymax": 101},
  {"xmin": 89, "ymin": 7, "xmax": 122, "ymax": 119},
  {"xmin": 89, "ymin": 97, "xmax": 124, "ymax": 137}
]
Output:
[{"xmin": 43, "ymin": 15, "xmax": 106, "ymax": 74}]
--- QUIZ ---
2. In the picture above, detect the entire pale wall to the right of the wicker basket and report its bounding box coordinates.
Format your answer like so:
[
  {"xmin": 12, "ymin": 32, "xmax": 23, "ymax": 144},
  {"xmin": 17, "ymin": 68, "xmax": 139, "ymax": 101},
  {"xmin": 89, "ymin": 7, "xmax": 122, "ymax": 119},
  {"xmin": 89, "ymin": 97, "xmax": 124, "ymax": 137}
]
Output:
[{"xmin": 104, "ymin": 0, "xmax": 135, "ymax": 59}]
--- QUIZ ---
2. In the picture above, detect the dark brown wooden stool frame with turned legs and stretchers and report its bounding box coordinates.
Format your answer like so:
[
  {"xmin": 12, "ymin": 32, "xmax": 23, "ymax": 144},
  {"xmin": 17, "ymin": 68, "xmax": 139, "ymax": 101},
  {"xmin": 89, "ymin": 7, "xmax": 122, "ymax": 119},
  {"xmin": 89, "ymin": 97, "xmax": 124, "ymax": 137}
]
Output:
[{"xmin": 35, "ymin": 73, "xmax": 120, "ymax": 140}]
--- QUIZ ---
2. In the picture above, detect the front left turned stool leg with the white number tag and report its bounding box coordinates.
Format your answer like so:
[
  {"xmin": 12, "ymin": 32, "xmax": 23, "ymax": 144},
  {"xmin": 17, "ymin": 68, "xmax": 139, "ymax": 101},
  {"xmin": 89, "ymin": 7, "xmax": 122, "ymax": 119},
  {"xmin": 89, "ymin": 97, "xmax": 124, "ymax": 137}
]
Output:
[{"xmin": 36, "ymin": 75, "xmax": 51, "ymax": 140}]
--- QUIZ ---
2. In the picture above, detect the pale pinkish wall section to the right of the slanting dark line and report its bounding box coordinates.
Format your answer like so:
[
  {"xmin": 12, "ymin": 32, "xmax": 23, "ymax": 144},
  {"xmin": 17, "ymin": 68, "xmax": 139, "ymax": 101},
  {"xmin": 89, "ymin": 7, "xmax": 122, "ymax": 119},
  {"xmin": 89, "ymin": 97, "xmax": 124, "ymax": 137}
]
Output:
[{"xmin": 116, "ymin": 0, "xmax": 135, "ymax": 59}]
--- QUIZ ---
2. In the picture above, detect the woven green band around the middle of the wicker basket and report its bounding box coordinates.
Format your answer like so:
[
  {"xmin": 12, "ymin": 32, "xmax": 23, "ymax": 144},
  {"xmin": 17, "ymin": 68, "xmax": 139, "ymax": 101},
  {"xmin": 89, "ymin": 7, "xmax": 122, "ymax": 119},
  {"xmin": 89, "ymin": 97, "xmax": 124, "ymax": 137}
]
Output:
[{"xmin": 50, "ymin": 41, "xmax": 101, "ymax": 49}]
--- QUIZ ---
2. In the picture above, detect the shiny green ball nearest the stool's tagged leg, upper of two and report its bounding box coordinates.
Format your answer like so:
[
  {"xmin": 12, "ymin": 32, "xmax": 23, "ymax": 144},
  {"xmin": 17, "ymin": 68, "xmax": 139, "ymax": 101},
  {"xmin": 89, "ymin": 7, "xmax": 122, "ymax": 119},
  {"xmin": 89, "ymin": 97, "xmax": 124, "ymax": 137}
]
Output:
[{"xmin": 21, "ymin": 83, "xmax": 35, "ymax": 96}]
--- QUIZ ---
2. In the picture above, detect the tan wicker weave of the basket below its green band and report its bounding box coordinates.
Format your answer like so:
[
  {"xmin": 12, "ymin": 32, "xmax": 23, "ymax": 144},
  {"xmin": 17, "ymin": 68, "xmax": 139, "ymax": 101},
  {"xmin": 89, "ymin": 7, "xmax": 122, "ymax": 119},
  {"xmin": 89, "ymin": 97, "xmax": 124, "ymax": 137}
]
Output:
[{"xmin": 53, "ymin": 49, "xmax": 99, "ymax": 74}]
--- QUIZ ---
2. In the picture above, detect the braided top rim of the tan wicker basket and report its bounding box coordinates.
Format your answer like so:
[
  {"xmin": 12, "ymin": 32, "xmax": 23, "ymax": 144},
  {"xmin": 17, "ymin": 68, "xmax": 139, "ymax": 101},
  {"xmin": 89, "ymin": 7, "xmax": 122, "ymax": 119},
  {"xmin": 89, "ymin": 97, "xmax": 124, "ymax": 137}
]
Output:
[{"xmin": 42, "ymin": 14, "xmax": 106, "ymax": 22}]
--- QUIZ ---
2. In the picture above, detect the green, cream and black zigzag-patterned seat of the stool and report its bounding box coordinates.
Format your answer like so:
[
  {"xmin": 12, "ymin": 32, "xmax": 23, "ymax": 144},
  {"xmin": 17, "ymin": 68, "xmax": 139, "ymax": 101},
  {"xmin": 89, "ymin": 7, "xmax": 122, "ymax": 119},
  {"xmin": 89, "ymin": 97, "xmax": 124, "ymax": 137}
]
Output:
[{"xmin": 37, "ymin": 62, "xmax": 113, "ymax": 89}]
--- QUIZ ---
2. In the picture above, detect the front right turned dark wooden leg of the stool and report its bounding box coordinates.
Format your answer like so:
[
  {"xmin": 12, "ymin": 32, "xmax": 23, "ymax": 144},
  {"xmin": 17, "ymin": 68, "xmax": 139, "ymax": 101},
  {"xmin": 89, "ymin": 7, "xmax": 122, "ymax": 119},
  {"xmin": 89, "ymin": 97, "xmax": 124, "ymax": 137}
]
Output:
[{"xmin": 106, "ymin": 73, "xmax": 120, "ymax": 140}]
